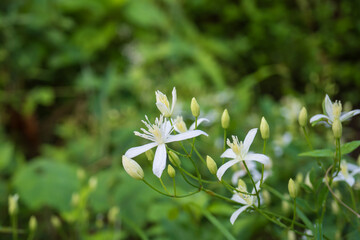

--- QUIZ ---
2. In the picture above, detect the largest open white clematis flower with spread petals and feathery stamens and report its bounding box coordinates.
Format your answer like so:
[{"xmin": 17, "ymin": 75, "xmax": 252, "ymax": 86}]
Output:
[{"xmin": 125, "ymin": 115, "xmax": 208, "ymax": 178}]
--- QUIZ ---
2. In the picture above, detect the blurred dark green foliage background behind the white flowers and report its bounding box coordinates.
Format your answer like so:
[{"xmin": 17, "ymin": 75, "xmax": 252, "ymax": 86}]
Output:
[{"xmin": 0, "ymin": 0, "xmax": 360, "ymax": 239}]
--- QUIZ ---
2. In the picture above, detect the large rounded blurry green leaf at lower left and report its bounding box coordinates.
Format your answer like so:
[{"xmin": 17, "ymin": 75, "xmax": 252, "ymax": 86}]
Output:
[{"xmin": 14, "ymin": 159, "xmax": 80, "ymax": 211}]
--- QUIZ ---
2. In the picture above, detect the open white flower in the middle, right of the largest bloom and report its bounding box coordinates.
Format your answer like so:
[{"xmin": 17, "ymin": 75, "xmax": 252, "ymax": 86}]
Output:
[{"xmin": 216, "ymin": 128, "xmax": 270, "ymax": 180}]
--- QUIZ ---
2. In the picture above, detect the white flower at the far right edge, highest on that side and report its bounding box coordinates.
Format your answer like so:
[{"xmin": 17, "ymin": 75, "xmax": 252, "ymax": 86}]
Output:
[{"xmin": 310, "ymin": 94, "xmax": 360, "ymax": 125}]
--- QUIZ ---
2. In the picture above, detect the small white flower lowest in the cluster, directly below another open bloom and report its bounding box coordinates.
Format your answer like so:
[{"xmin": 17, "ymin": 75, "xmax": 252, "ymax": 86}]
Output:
[{"xmin": 230, "ymin": 181, "xmax": 260, "ymax": 224}]
